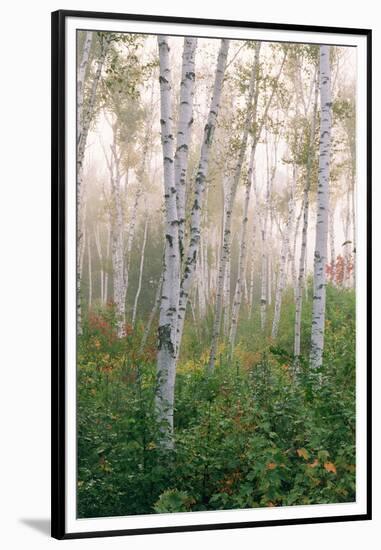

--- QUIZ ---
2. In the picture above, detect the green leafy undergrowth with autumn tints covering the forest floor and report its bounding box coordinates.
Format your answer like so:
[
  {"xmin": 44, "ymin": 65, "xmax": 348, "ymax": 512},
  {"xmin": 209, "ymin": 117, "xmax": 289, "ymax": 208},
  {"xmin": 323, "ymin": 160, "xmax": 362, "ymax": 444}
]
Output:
[{"xmin": 78, "ymin": 286, "xmax": 356, "ymax": 517}]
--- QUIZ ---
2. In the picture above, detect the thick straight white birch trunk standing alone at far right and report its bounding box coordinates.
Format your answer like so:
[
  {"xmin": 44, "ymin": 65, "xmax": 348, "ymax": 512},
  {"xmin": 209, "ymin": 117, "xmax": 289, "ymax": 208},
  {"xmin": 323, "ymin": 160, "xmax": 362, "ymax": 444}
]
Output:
[{"xmin": 310, "ymin": 46, "xmax": 331, "ymax": 369}]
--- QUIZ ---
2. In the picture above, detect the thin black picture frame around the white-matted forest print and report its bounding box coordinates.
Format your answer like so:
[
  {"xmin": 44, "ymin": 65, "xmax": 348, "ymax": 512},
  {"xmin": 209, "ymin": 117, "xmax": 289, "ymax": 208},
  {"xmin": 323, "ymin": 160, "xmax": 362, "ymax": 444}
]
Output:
[{"xmin": 51, "ymin": 10, "xmax": 372, "ymax": 539}]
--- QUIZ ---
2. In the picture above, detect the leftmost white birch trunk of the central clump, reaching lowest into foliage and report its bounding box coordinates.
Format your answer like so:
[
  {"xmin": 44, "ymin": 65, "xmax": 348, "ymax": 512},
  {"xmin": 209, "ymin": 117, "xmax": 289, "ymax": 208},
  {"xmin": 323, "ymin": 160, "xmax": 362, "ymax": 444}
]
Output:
[{"xmin": 156, "ymin": 36, "xmax": 180, "ymax": 448}]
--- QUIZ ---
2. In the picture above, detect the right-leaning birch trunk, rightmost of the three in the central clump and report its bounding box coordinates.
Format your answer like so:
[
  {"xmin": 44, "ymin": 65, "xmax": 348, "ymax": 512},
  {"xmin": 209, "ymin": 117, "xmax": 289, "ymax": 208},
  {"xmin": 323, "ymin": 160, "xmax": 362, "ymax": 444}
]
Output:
[{"xmin": 176, "ymin": 39, "xmax": 229, "ymax": 362}]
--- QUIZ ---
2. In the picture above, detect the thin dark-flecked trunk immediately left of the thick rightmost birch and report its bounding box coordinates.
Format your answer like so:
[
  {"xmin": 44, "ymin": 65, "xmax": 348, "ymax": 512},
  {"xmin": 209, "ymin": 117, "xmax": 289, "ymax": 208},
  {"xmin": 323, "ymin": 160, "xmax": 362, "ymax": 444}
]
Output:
[{"xmin": 294, "ymin": 70, "xmax": 319, "ymax": 366}]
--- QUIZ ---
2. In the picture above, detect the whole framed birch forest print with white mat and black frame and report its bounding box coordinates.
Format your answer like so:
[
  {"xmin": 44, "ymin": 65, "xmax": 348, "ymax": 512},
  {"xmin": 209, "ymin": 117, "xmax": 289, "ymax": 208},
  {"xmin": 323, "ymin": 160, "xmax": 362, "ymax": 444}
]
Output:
[{"xmin": 52, "ymin": 11, "xmax": 371, "ymax": 539}]
